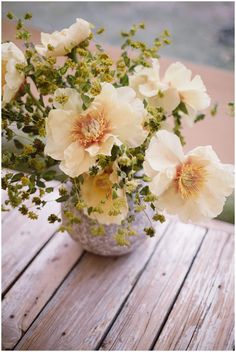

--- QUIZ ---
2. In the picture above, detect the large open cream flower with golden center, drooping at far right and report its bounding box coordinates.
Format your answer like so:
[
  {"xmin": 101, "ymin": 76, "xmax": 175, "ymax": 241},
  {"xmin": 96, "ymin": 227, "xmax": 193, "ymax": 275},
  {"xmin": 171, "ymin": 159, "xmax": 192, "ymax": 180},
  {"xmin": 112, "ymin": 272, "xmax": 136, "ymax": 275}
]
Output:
[{"xmin": 144, "ymin": 130, "xmax": 234, "ymax": 223}]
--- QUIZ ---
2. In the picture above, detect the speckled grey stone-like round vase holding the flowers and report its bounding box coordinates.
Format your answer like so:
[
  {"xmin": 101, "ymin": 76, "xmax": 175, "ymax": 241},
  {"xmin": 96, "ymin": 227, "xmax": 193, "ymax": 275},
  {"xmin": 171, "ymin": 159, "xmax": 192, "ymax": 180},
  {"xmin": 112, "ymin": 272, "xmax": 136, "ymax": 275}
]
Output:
[{"xmin": 62, "ymin": 203, "xmax": 150, "ymax": 257}]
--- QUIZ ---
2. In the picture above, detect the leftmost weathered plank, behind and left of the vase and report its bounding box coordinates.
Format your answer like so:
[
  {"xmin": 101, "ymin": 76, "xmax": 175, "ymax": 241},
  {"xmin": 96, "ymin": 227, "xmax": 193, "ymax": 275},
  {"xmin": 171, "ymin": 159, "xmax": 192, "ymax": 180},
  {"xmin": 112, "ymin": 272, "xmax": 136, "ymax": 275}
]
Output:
[{"xmin": 2, "ymin": 202, "xmax": 60, "ymax": 292}]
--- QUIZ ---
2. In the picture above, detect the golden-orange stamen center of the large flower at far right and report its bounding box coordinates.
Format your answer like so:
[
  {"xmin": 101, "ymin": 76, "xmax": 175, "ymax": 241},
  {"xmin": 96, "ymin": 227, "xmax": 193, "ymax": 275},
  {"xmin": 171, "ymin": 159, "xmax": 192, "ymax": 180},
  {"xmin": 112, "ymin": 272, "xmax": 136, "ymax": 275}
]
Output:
[{"xmin": 174, "ymin": 160, "xmax": 207, "ymax": 199}]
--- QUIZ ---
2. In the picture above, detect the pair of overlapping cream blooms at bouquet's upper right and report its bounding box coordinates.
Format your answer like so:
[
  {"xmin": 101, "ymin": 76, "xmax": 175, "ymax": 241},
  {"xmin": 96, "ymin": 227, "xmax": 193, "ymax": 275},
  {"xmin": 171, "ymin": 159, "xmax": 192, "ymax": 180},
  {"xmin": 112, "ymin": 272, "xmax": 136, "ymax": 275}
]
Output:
[{"xmin": 130, "ymin": 59, "xmax": 210, "ymax": 118}]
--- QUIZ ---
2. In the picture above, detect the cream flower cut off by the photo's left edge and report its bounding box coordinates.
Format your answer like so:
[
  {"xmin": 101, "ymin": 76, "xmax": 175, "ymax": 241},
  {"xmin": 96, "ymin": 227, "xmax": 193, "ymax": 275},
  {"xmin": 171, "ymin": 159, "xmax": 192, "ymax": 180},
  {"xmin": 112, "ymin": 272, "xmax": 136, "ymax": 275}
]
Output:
[{"xmin": 2, "ymin": 42, "xmax": 27, "ymax": 104}]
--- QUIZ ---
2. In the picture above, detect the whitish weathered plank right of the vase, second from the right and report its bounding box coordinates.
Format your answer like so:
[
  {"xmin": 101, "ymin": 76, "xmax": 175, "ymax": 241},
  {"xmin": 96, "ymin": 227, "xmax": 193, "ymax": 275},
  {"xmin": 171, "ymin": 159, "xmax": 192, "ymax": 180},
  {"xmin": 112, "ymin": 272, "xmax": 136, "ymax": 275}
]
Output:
[{"xmin": 101, "ymin": 223, "xmax": 206, "ymax": 351}]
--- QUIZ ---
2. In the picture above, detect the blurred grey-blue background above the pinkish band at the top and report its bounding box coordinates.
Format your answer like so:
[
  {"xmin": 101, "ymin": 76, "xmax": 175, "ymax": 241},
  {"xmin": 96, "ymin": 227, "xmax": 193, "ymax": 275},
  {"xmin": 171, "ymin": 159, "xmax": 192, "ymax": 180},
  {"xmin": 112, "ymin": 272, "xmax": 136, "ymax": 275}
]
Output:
[{"xmin": 2, "ymin": 1, "xmax": 234, "ymax": 70}]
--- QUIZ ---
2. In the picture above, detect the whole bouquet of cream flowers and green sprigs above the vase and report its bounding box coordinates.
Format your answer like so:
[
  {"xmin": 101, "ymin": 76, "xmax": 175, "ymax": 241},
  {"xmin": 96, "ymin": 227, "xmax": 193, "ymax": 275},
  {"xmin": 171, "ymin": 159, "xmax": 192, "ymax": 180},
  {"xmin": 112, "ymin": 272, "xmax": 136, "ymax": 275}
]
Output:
[{"xmin": 2, "ymin": 13, "xmax": 233, "ymax": 245}]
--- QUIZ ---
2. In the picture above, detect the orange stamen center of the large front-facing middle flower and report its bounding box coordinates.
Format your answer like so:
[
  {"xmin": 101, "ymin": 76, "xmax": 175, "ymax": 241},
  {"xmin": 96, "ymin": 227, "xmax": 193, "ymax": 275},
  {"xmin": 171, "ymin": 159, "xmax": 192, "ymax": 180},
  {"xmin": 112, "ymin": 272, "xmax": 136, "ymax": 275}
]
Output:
[{"xmin": 72, "ymin": 113, "xmax": 108, "ymax": 148}]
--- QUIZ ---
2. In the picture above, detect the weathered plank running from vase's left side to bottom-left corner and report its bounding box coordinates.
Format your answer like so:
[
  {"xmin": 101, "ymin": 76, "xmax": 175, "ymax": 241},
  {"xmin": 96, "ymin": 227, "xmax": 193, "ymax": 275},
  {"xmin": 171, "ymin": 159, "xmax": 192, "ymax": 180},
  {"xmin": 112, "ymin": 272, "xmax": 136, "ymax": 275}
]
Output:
[{"xmin": 2, "ymin": 233, "xmax": 82, "ymax": 349}]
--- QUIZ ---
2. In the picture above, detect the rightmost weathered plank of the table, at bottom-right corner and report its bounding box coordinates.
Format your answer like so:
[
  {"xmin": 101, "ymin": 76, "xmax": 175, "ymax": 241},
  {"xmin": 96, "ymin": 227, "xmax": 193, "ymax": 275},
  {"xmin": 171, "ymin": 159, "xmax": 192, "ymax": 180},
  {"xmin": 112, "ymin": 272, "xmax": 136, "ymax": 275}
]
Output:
[{"xmin": 155, "ymin": 230, "xmax": 234, "ymax": 351}]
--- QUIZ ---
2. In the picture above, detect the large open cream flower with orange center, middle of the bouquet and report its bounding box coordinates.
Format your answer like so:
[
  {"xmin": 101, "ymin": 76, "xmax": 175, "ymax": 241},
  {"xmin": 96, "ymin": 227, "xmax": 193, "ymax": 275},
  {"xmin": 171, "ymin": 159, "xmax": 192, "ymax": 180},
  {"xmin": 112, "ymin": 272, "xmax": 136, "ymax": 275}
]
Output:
[{"xmin": 45, "ymin": 83, "xmax": 147, "ymax": 177}]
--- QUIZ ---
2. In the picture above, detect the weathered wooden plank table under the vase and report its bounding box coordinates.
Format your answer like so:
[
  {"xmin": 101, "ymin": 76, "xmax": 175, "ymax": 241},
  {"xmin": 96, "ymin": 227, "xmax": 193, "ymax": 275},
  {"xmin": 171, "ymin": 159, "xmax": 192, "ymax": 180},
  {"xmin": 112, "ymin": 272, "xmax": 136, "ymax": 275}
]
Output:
[{"xmin": 2, "ymin": 188, "xmax": 234, "ymax": 350}]
